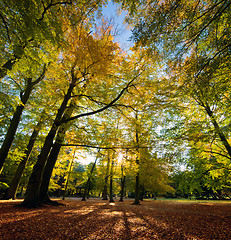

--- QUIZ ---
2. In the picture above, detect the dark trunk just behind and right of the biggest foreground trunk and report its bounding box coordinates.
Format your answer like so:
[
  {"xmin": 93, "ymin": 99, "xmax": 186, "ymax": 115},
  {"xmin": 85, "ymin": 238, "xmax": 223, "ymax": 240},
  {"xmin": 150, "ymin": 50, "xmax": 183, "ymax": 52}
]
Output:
[{"xmin": 39, "ymin": 105, "xmax": 74, "ymax": 203}]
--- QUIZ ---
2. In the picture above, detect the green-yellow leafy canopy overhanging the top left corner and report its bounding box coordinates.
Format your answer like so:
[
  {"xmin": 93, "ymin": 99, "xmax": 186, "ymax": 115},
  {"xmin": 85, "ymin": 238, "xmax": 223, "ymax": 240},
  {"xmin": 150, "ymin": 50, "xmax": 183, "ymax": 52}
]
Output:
[{"xmin": 0, "ymin": 0, "xmax": 103, "ymax": 78}]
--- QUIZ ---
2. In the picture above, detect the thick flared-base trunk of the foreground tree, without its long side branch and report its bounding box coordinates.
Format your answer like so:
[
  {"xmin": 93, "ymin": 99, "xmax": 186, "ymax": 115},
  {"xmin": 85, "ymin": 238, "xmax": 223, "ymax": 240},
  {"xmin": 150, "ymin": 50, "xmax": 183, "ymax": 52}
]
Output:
[{"xmin": 21, "ymin": 84, "xmax": 75, "ymax": 207}]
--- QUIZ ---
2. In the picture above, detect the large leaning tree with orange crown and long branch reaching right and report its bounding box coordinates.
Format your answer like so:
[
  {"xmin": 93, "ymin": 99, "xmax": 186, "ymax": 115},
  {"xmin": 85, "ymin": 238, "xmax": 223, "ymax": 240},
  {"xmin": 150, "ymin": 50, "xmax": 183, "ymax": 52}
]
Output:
[{"xmin": 22, "ymin": 17, "xmax": 143, "ymax": 206}]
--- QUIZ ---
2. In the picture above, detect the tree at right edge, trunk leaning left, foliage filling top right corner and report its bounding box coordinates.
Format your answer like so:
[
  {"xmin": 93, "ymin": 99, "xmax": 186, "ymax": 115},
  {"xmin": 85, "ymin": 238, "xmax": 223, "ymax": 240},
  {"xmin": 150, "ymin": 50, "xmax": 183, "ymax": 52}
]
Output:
[{"xmin": 124, "ymin": 1, "xmax": 231, "ymax": 158}]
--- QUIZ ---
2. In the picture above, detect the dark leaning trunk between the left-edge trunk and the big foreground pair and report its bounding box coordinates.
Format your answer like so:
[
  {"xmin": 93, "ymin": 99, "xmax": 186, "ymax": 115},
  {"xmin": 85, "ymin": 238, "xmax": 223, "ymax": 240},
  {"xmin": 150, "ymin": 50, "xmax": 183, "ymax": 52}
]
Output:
[{"xmin": 7, "ymin": 117, "xmax": 43, "ymax": 199}]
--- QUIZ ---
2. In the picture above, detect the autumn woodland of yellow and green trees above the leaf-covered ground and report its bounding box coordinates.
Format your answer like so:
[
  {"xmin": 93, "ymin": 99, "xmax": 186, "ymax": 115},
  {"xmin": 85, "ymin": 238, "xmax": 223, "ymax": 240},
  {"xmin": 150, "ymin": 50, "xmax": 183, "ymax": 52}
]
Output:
[{"xmin": 0, "ymin": 0, "xmax": 231, "ymax": 207}]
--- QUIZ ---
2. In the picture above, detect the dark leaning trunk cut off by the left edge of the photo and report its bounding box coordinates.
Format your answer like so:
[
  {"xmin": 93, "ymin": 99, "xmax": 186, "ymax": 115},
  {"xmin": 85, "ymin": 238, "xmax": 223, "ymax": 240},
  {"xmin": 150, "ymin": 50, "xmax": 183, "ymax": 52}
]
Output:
[{"xmin": 0, "ymin": 81, "xmax": 33, "ymax": 174}]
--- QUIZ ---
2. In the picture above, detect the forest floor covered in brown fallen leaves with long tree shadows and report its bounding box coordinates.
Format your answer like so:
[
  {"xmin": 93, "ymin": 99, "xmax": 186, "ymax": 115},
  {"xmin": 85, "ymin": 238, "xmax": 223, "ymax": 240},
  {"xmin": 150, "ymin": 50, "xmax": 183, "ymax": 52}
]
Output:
[{"xmin": 0, "ymin": 199, "xmax": 231, "ymax": 240}]
